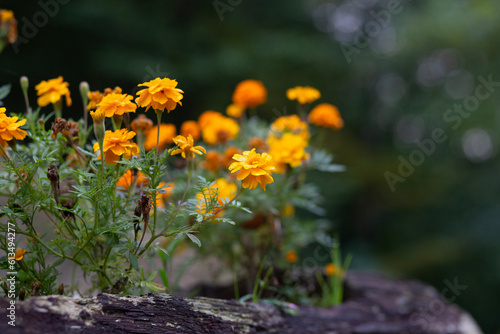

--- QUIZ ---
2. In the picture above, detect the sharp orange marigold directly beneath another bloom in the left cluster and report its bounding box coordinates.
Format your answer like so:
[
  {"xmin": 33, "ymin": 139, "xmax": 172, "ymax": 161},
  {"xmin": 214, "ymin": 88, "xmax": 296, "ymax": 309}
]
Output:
[{"xmin": 94, "ymin": 129, "xmax": 139, "ymax": 165}]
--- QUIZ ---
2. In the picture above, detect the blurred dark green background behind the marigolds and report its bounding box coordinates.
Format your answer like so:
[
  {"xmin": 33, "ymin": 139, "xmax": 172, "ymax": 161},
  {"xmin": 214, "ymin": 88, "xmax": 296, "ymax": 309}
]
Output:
[{"xmin": 0, "ymin": 0, "xmax": 500, "ymax": 333}]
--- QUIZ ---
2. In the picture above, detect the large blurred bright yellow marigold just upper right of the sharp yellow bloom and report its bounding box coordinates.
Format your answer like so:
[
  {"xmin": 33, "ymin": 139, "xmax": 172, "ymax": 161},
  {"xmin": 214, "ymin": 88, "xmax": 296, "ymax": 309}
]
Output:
[{"xmin": 268, "ymin": 132, "xmax": 309, "ymax": 173}]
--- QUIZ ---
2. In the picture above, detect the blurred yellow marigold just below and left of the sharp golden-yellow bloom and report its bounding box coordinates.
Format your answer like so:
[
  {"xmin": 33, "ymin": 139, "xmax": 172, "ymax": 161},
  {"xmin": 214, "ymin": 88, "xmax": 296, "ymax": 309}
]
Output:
[{"xmin": 196, "ymin": 178, "xmax": 238, "ymax": 218}]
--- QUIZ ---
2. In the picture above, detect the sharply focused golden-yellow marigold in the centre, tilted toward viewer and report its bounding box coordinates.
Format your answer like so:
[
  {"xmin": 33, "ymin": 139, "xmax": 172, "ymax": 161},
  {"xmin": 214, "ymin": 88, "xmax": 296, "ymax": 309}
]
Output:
[{"xmin": 229, "ymin": 149, "xmax": 274, "ymax": 191}]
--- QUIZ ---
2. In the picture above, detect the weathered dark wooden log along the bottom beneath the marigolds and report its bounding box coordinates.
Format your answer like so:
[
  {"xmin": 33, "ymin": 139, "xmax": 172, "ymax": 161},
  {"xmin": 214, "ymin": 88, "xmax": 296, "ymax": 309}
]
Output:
[{"xmin": 0, "ymin": 272, "xmax": 481, "ymax": 334}]
